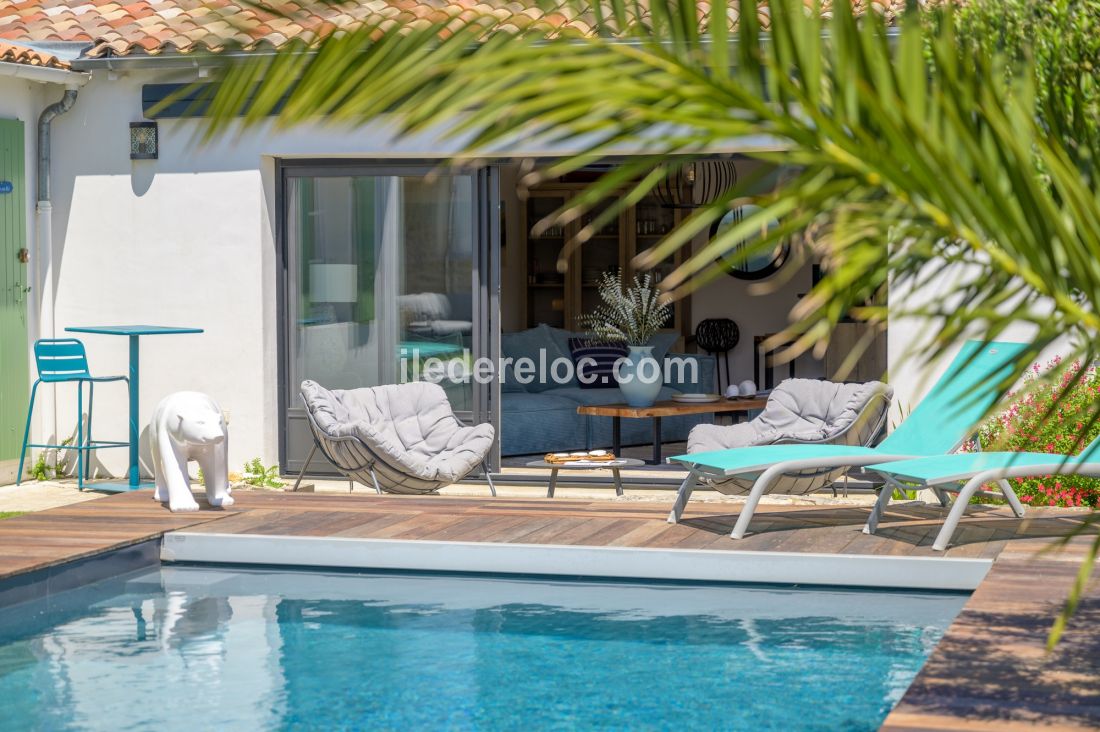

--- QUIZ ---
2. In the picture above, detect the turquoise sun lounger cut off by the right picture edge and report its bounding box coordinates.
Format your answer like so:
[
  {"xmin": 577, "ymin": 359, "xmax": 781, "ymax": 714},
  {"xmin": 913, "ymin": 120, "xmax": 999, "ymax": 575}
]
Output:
[{"xmin": 864, "ymin": 438, "xmax": 1100, "ymax": 551}]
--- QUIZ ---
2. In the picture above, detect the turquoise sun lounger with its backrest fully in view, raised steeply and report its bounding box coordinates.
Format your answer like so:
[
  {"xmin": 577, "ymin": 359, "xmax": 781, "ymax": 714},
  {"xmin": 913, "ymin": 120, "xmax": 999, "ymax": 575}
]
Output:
[{"xmin": 669, "ymin": 340, "xmax": 1027, "ymax": 539}]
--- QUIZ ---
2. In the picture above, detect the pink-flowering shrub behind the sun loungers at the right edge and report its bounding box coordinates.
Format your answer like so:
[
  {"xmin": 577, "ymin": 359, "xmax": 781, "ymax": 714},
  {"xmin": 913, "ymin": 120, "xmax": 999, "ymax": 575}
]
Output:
[{"xmin": 967, "ymin": 359, "xmax": 1100, "ymax": 509}]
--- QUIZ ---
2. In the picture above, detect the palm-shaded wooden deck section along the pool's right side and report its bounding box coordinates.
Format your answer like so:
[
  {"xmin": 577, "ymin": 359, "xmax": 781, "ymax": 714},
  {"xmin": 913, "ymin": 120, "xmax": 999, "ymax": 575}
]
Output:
[{"xmin": 882, "ymin": 535, "xmax": 1100, "ymax": 732}]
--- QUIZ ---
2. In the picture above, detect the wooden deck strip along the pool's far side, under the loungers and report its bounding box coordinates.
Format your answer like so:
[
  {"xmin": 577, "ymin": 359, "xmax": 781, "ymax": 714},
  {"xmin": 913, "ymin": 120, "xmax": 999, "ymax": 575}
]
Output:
[{"xmin": 167, "ymin": 493, "xmax": 1081, "ymax": 559}]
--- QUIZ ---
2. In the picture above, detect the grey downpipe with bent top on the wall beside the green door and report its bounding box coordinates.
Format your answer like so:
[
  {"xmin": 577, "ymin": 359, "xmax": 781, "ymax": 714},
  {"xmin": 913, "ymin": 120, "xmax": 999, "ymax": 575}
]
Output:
[{"xmin": 32, "ymin": 89, "xmax": 77, "ymax": 457}]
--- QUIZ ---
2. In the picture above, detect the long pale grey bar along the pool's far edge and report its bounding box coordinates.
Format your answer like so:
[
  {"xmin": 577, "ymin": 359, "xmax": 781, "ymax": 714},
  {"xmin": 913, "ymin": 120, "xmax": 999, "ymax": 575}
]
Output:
[{"xmin": 161, "ymin": 529, "xmax": 993, "ymax": 591}]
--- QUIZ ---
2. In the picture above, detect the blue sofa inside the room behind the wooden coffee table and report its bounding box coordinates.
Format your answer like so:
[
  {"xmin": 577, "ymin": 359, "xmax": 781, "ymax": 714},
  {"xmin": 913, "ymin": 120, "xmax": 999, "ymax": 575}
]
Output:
[{"xmin": 501, "ymin": 325, "xmax": 716, "ymax": 456}]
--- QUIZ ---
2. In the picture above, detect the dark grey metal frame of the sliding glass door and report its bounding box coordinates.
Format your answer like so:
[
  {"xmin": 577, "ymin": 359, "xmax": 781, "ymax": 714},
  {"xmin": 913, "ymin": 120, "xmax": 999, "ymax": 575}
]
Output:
[{"xmin": 275, "ymin": 159, "xmax": 501, "ymax": 476}]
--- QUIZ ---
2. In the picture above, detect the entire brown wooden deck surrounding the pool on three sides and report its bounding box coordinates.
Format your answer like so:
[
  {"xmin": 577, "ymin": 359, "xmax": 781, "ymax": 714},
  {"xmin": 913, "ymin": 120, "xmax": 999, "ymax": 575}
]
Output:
[{"xmin": 0, "ymin": 491, "xmax": 1100, "ymax": 730}]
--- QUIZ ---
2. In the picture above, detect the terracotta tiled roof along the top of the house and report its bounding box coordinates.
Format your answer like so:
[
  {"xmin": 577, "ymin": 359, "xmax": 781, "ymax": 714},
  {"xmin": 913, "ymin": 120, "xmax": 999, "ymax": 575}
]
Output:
[{"xmin": 0, "ymin": 0, "xmax": 919, "ymax": 57}]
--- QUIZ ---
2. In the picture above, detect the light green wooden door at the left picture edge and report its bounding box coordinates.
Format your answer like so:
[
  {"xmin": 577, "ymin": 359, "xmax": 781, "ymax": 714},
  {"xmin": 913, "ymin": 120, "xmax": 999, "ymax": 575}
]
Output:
[{"xmin": 0, "ymin": 120, "xmax": 30, "ymax": 464}]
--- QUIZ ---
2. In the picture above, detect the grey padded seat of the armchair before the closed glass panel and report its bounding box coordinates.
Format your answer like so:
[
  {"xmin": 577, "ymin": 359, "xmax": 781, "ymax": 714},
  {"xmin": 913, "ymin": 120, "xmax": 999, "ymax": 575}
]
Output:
[{"xmin": 301, "ymin": 381, "xmax": 495, "ymax": 490}]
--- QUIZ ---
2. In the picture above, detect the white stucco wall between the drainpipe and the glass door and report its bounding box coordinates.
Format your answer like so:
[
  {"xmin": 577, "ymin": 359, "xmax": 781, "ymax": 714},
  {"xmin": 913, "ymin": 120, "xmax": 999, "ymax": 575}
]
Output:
[{"xmin": 53, "ymin": 73, "xmax": 270, "ymax": 474}]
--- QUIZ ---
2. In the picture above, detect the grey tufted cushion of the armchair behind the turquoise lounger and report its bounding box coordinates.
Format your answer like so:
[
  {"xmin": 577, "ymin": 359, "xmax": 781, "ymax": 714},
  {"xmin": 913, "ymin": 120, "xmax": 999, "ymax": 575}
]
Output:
[{"xmin": 688, "ymin": 379, "xmax": 893, "ymax": 452}]
